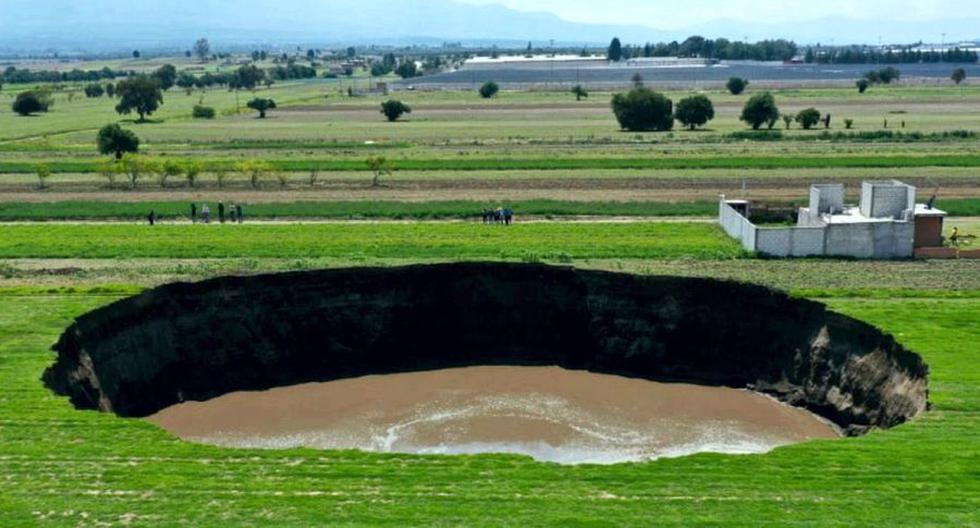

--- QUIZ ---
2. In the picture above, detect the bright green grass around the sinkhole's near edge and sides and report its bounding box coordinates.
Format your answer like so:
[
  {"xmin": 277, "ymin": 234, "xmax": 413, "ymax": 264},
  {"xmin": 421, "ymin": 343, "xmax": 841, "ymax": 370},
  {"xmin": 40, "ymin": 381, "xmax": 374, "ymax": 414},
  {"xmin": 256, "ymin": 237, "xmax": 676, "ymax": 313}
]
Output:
[{"xmin": 0, "ymin": 288, "xmax": 980, "ymax": 527}]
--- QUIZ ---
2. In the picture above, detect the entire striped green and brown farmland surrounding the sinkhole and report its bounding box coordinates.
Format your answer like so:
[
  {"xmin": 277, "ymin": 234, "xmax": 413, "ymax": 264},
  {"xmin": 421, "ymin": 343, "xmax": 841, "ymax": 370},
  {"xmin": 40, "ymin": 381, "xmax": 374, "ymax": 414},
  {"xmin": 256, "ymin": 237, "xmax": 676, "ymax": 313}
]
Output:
[{"xmin": 0, "ymin": 50, "xmax": 980, "ymax": 527}]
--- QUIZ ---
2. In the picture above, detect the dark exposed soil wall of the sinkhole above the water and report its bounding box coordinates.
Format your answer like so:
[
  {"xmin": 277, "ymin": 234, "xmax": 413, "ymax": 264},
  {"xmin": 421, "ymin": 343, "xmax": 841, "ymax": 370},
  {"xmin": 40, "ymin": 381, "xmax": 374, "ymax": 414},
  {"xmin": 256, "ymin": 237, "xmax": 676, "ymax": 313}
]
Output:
[{"xmin": 44, "ymin": 263, "xmax": 928, "ymax": 434}]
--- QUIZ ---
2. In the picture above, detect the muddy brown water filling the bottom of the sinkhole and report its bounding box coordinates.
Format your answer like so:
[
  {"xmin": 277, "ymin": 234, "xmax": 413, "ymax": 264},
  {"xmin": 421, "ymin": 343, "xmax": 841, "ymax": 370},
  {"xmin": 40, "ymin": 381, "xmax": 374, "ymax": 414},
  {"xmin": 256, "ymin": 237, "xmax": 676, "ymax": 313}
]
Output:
[{"xmin": 149, "ymin": 367, "xmax": 838, "ymax": 464}]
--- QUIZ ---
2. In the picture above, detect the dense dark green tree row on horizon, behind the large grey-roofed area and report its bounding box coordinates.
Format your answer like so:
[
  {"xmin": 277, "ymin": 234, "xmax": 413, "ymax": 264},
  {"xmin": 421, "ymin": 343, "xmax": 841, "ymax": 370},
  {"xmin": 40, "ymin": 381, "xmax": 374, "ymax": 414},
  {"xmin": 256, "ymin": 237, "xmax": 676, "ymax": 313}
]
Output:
[{"xmin": 607, "ymin": 35, "xmax": 799, "ymax": 61}]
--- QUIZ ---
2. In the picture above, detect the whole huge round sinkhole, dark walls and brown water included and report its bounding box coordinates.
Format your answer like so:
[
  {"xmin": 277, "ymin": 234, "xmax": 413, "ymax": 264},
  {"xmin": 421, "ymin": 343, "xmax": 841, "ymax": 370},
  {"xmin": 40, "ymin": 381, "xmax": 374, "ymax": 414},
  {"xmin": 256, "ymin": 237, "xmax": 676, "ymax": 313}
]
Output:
[{"xmin": 43, "ymin": 263, "xmax": 928, "ymax": 463}]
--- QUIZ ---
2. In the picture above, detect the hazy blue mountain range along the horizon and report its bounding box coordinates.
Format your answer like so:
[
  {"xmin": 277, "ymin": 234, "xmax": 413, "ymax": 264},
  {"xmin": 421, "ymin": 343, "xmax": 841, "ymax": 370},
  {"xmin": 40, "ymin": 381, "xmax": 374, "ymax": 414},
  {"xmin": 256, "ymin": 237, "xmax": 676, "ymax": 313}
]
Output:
[{"xmin": 0, "ymin": 0, "xmax": 980, "ymax": 52}]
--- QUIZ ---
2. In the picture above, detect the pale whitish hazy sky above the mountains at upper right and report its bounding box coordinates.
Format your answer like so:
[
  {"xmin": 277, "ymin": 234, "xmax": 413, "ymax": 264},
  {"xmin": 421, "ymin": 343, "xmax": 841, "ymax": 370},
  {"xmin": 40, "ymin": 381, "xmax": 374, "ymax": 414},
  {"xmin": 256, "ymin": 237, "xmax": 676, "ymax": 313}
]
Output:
[{"xmin": 457, "ymin": 0, "xmax": 980, "ymax": 30}]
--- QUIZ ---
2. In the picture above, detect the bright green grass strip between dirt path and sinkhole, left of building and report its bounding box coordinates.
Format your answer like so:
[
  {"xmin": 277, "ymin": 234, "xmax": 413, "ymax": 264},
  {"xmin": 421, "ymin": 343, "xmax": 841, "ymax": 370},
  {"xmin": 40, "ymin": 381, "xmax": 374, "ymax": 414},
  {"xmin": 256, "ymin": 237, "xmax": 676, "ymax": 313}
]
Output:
[{"xmin": 0, "ymin": 221, "xmax": 743, "ymax": 260}]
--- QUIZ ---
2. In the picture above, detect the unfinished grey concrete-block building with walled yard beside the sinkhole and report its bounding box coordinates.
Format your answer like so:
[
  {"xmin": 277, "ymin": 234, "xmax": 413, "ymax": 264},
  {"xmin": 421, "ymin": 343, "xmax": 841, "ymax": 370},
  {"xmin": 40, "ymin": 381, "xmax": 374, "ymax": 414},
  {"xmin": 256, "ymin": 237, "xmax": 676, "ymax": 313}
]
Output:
[{"xmin": 719, "ymin": 180, "xmax": 946, "ymax": 259}]
